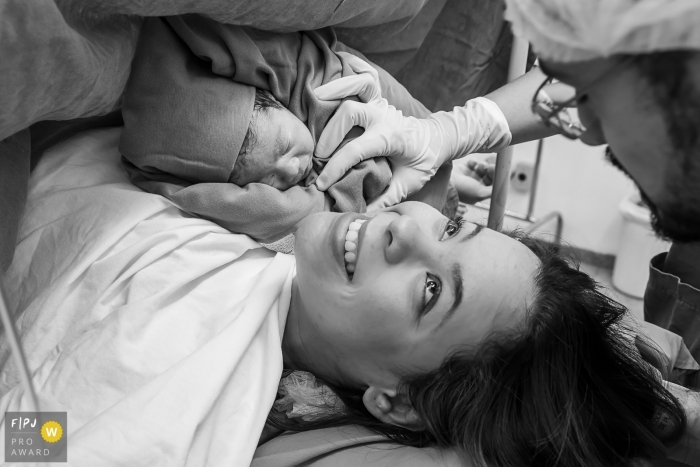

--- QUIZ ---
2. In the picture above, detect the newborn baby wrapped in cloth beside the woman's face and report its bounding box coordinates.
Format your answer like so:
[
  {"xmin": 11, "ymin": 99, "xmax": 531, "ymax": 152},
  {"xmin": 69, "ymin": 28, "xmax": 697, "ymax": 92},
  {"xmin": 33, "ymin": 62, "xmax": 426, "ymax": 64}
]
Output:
[{"xmin": 119, "ymin": 15, "xmax": 498, "ymax": 251}]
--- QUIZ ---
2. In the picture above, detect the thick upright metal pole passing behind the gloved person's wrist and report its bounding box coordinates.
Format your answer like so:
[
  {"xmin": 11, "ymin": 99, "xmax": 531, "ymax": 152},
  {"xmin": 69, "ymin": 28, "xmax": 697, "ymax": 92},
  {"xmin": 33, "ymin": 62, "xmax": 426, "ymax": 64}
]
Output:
[{"xmin": 487, "ymin": 36, "xmax": 528, "ymax": 230}]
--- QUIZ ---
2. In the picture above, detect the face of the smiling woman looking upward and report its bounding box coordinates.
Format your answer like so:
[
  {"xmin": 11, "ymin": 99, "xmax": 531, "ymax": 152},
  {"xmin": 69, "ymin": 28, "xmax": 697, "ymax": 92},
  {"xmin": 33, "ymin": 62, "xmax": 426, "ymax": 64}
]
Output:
[{"xmin": 284, "ymin": 202, "xmax": 539, "ymax": 387}]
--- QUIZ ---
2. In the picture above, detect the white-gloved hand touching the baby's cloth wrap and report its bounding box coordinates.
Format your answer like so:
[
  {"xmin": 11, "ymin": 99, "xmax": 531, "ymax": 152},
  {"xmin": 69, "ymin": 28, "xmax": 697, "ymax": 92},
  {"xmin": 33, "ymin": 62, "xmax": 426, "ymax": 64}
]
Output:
[{"xmin": 314, "ymin": 78, "xmax": 511, "ymax": 210}]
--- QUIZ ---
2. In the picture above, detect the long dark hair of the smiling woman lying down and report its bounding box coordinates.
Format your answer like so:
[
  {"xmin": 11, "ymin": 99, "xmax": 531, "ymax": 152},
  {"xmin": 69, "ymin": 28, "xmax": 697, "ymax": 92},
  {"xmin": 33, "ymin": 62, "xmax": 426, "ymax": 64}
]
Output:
[{"xmin": 268, "ymin": 233, "xmax": 686, "ymax": 467}]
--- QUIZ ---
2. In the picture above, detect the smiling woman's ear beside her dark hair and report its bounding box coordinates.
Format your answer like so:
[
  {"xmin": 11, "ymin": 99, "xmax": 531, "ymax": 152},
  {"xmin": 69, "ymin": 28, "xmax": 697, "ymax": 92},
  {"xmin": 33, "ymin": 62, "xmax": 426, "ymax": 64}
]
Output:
[{"xmin": 362, "ymin": 386, "xmax": 425, "ymax": 431}]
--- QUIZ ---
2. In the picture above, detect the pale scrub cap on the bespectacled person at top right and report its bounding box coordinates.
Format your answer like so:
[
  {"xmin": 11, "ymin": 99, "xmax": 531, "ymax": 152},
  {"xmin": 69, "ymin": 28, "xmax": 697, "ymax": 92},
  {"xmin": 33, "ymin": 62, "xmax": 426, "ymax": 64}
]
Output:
[{"xmin": 506, "ymin": 0, "xmax": 700, "ymax": 62}]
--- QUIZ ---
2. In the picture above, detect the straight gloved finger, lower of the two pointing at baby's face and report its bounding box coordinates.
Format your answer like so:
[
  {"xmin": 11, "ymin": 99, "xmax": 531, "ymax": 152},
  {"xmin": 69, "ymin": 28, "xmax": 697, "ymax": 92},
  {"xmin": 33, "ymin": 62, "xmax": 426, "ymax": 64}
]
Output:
[{"xmin": 316, "ymin": 133, "xmax": 387, "ymax": 191}]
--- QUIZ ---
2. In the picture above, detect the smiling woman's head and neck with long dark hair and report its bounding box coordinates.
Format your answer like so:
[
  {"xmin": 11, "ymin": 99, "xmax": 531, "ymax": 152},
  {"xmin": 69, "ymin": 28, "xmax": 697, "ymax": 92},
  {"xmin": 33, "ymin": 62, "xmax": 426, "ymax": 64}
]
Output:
[{"xmin": 269, "ymin": 203, "xmax": 685, "ymax": 466}]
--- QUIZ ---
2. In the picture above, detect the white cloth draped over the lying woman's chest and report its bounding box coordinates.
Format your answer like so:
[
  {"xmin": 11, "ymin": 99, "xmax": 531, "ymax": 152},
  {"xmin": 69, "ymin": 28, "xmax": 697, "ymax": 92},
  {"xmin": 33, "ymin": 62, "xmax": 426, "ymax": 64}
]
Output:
[{"xmin": 0, "ymin": 129, "xmax": 295, "ymax": 467}]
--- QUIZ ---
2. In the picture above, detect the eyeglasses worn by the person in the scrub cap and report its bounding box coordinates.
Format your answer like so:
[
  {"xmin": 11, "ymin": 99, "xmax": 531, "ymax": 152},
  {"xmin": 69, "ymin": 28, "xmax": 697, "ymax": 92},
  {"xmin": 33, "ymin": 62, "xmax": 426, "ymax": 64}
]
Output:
[{"xmin": 530, "ymin": 59, "xmax": 630, "ymax": 139}]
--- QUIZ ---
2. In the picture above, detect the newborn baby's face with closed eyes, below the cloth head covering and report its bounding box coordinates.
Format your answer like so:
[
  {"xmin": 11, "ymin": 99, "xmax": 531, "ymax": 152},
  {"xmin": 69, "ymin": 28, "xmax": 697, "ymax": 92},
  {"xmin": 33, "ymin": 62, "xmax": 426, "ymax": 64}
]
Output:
[{"xmin": 229, "ymin": 89, "xmax": 314, "ymax": 190}]
